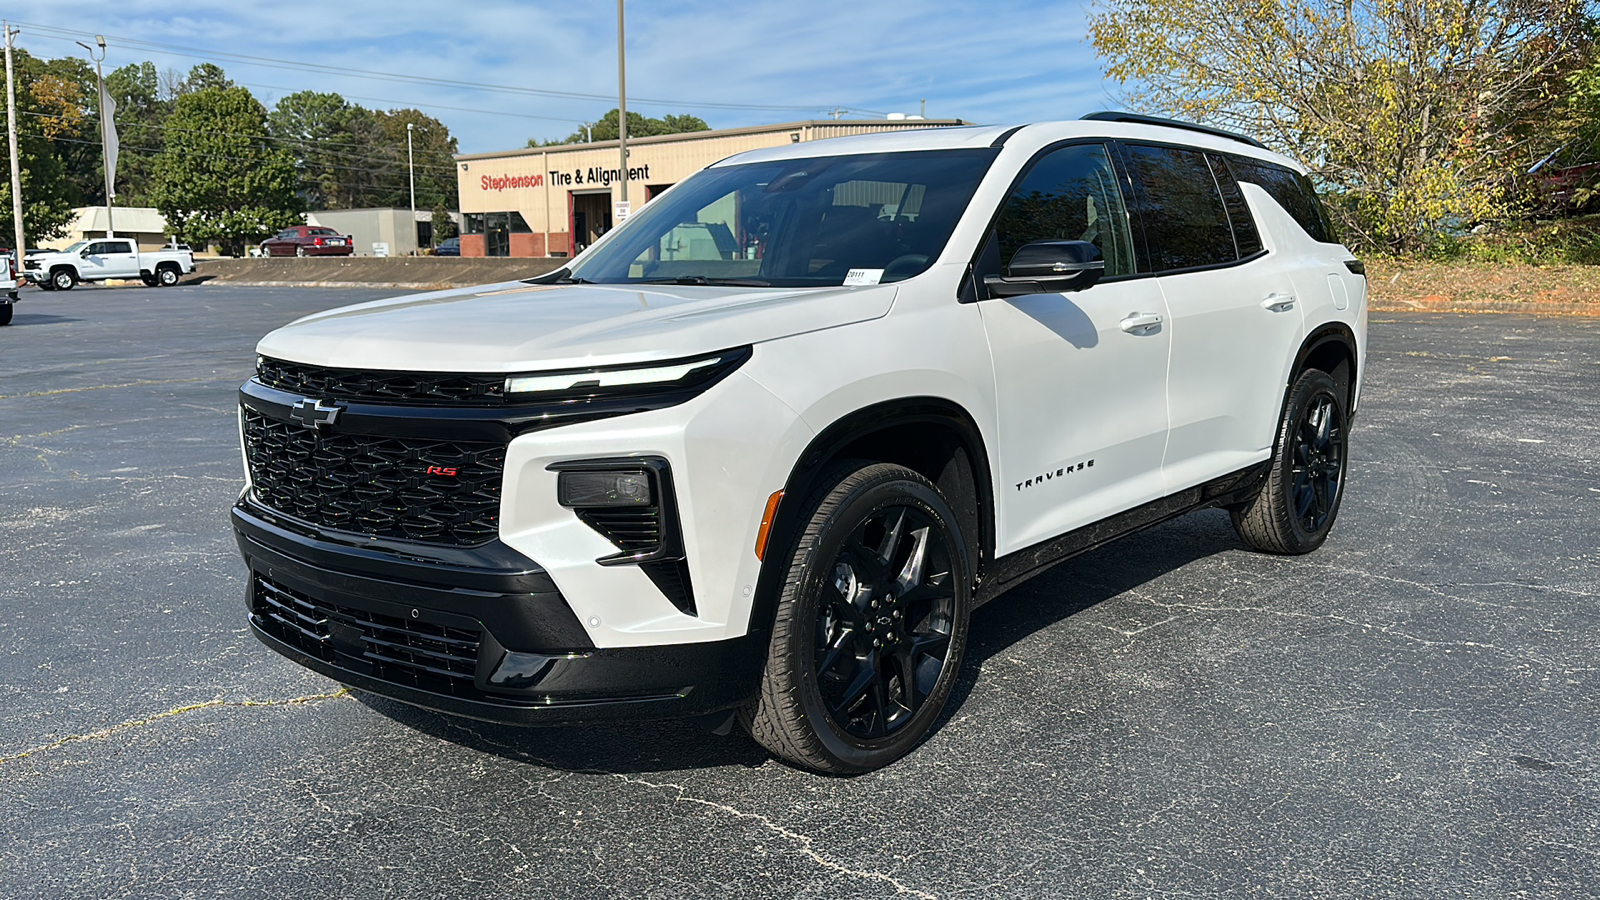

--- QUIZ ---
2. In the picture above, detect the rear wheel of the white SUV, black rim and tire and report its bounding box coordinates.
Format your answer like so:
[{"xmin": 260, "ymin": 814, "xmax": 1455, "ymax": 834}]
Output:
[{"xmin": 1232, "ymin": 368, "xmax": 1350, "ymax": 554}]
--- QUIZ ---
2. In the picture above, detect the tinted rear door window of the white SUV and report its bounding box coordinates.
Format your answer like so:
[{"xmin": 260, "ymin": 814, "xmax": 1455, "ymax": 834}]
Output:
[{"xmin": 1128, "ymin": 144, "xmax": 1238, "ymax": 272}]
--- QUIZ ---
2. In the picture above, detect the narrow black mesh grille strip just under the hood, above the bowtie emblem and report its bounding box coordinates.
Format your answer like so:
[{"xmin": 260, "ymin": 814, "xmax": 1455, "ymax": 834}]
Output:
[{"xmin": 256, "ymin": 357, "xmax": 506, "ymax": 407}]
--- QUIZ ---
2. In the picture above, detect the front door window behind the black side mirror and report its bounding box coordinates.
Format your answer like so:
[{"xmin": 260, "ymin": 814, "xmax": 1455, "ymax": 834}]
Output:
[{"xmin": 995, "ymin": 144, "xmax": 1134, "ymax": 277}]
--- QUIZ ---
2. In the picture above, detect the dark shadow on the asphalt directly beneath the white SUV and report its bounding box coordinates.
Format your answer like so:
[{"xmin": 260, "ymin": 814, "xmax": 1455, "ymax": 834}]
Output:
[{"xmin": 354, "ymin": 511, "xmax": 1243, "ymax": 775}]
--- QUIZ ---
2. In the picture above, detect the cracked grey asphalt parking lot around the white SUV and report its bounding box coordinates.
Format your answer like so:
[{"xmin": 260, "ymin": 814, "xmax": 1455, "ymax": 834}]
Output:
[{"xmin": 0, "ymin": 285, "xmax": 1600, "ymax": 898}]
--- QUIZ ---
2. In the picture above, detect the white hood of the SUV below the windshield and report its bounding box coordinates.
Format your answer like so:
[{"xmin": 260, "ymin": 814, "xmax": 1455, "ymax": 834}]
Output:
[{"xmin": 256, "ymin": 282, "xmax": 896, "ymax": 372}]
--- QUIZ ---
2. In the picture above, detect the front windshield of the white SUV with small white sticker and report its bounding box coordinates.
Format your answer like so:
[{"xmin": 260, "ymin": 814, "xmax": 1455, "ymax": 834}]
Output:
[{"xmin": 571, "ymin": 149, "xmax": 995, "ymax": 287}]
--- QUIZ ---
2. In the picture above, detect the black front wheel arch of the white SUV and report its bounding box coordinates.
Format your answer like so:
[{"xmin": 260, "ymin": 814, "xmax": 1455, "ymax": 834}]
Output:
[{"xmin": 749, "ymin": 397, "xmax": 995, "ymax": 633}]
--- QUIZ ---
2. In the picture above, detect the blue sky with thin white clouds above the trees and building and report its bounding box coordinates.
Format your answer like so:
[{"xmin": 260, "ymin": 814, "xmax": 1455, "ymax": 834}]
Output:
[{"xmin": 6, "ymin": 0, "xmax": 1118, "ymax": 152}]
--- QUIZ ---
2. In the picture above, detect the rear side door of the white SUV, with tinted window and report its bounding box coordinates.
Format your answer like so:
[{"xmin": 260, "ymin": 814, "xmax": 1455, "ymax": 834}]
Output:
[{"xmin": 1125, "ymin": 144, "xmax": 1304, "ymax": 493}]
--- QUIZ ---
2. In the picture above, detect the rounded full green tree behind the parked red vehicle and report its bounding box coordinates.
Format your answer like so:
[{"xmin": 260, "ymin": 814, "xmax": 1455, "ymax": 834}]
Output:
[{"xmin": 150, "ymin": 86, "xmax": 304, "ymax": 256}]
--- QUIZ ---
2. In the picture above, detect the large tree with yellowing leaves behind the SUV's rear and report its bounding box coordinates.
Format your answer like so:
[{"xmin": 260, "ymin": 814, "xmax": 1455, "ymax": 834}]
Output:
[{"xmin": 1090, "ymin": 0, "xmax": 1590, "ymax": 250}]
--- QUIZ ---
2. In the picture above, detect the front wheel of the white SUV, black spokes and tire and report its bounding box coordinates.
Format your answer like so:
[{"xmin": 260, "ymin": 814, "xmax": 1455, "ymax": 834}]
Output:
[{"xmin": 741, "ymin": 461, "xmax": 973, "ymax": 775}]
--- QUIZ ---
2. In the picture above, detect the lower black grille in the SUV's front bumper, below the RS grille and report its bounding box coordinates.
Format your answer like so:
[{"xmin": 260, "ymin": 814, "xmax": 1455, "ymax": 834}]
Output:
[{"xmin": 250, "ymin": 575, "xmax": 485, "ymax": 700}]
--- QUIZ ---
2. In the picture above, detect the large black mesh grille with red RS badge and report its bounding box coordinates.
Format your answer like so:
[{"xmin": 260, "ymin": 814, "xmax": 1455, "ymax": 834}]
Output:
[{"xmin": 243, "ymin": 408, "xmax": 506, "ymax": 546}]
